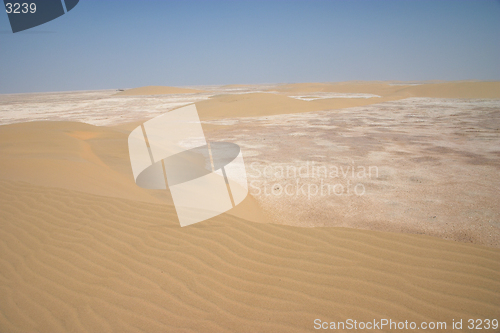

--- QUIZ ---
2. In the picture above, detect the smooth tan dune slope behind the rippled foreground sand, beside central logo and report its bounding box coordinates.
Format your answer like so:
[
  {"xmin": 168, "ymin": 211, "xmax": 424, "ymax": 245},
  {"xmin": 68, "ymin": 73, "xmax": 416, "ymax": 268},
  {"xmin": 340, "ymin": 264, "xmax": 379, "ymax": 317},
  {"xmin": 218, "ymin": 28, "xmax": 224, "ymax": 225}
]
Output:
[{"xmin": 0, "ymin": 122, "xmax": 267, "ymax": 222}]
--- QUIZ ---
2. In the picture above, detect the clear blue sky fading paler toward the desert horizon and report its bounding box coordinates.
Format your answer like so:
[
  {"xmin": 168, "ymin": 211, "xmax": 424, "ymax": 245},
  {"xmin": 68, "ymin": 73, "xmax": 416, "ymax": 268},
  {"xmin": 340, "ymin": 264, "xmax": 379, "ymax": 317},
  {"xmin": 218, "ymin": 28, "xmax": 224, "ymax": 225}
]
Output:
[{"xmin": 0, "ymin": 0, "xmax": 500, "ymax": 93}]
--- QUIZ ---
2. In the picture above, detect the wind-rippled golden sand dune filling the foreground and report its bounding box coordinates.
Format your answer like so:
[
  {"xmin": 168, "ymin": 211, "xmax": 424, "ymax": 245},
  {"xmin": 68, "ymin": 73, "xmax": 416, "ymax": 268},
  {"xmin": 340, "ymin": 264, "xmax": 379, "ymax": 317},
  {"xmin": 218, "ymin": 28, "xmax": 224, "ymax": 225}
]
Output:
[{"xmin": 0, "ymin": 181, "xmax": 500, "ymax": 332}]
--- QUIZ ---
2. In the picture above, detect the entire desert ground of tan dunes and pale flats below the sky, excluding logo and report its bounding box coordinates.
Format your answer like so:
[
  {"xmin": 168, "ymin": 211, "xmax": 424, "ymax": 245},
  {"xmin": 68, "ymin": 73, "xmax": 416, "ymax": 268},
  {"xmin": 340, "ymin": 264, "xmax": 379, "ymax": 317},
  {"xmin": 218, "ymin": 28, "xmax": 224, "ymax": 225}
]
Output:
[{"xmin": 0, "ymin": 82, "xmax": 500, "ymax": 332}]
